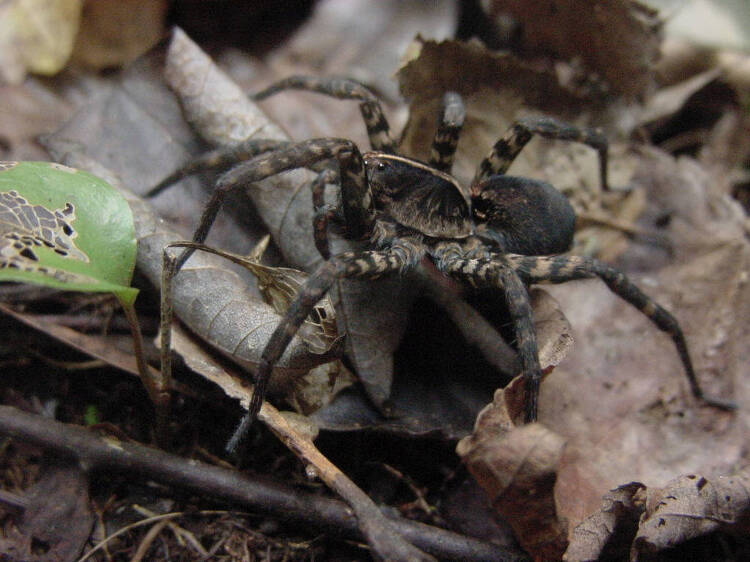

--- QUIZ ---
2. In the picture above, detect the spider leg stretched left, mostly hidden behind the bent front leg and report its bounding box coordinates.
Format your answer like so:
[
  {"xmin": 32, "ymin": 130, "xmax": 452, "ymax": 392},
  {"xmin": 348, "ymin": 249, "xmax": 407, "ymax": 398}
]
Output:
[{"xmin": 145, "ymin": 139, "xmax": 292, "ymax": 197}]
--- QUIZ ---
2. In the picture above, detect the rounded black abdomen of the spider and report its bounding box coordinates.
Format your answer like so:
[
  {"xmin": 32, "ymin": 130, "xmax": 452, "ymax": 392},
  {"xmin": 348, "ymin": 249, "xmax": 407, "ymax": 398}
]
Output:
[{"xmin": 471, "ymin": 175, "xmax": 576, "ymax": 256}]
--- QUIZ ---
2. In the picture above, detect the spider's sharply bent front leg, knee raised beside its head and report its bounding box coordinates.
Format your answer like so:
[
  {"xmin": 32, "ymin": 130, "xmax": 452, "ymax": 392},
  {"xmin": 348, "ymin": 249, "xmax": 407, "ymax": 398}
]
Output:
[{"xmin": 176, "ymin": 138, "xmax": 375, "ymax": 271}]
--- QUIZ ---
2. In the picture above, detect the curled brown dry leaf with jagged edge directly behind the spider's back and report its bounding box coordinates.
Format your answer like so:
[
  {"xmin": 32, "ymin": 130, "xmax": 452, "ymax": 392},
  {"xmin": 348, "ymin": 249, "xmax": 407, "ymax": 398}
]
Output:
[{"xmin": 397, "ymin": 37, "xmax": 584, "ymax": 181}]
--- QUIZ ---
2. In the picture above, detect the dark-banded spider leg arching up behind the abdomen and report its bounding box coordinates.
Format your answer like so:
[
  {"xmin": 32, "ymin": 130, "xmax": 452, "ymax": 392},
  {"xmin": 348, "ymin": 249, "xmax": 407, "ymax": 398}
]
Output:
[{"xmin": 471, "ymin": 117, "xmax": 609, "ymax": 189}]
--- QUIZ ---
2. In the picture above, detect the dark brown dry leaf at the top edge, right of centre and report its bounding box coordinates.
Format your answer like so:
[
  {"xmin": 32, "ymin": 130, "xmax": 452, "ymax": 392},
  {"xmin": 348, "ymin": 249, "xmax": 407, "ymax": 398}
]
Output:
[{"xmin": 483, "ymin": 0, "xmax": 661, "ymax": 97}]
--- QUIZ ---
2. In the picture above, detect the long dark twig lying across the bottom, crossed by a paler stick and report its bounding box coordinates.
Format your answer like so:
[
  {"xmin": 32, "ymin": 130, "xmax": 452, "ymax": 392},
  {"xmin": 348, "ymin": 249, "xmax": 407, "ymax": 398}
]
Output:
[{"xmin": 0, "ymin": 406, "xmax": 525, "ymax": 561}]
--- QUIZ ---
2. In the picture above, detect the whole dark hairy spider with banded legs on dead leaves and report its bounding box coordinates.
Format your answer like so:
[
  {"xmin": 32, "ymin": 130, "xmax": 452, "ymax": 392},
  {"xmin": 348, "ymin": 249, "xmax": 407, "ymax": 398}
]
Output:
[{"xmin": 151, "ymin": 77, "xmax": 732, "ymax": 449}]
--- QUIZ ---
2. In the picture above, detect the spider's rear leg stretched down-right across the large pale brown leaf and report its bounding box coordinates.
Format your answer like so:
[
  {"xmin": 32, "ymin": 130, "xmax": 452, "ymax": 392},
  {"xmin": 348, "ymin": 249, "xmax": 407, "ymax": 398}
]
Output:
[{"xmin": 505, "ymin": 254, "xmax": 736, "ymax": 410}]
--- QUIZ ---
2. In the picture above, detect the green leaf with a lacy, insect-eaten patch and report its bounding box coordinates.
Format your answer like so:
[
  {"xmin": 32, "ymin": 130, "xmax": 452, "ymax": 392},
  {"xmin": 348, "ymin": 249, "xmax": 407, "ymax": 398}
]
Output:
[{"xmin": 0, "ymin": 162, "xmax": 138, "ymax": 304}]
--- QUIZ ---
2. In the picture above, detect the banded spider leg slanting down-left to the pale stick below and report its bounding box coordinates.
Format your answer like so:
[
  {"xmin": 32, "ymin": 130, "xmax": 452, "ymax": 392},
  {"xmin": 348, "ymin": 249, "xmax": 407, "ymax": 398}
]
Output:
[{"xmin": 227, "ymin": 243, "xmax": 422, "ymax": 451}]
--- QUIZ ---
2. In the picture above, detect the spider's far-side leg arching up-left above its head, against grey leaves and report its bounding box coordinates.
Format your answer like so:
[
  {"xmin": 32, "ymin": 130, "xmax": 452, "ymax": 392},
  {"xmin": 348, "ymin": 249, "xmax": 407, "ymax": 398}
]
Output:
[{"xmin": 251, "ymin": 76, "xmax": 396, "ymax": 154}]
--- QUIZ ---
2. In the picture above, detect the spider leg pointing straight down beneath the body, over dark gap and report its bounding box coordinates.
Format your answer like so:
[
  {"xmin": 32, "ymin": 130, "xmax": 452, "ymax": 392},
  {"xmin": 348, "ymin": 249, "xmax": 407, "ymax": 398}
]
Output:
[{"xmin": 433, "ymin": 245, "xmax": 542, "ymax": 423}]
